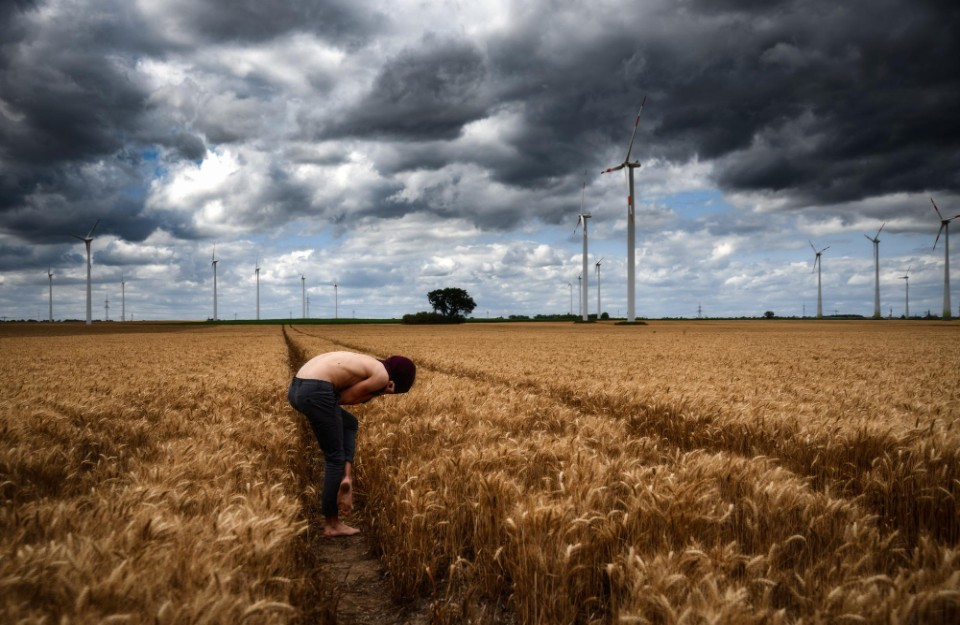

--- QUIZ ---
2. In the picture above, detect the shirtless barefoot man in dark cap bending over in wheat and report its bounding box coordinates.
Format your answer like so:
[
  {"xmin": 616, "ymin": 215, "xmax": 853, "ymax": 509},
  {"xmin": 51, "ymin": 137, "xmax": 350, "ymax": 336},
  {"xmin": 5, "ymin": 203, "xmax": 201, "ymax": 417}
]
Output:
[{"xmin": 287, "ymin": 352, "xmax": 417, "ymax": 536}]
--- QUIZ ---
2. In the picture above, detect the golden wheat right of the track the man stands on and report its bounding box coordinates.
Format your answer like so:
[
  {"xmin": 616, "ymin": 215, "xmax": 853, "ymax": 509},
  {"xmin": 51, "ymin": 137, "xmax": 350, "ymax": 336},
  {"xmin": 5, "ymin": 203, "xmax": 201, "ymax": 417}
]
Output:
[{"xmin": 292, "ymin": 324, "xmax": 960, "ymax": 623}]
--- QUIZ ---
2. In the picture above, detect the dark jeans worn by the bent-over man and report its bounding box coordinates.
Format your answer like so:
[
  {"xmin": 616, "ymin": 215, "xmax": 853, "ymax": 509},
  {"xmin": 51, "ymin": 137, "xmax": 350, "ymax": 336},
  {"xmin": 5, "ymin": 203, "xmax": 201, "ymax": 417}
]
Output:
[{"xmin": 287, "ymin": 378, "xmax": 359, "ymax": 517}]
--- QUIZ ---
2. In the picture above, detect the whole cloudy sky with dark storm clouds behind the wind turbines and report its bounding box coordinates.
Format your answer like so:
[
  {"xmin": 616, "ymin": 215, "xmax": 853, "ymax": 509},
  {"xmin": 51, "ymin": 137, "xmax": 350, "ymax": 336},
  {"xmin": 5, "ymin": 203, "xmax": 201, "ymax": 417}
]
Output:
[{"xmin": 0, "ymin": 0, "xmax": 960, "ymax": 319}]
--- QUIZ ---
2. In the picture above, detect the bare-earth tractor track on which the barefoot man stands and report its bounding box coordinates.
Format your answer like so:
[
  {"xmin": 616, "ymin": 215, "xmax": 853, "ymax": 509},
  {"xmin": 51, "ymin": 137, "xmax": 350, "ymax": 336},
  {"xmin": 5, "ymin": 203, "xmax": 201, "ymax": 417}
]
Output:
[{"xmin": 282, "ymin": 326, "xmax": 428, "ymax": 625}]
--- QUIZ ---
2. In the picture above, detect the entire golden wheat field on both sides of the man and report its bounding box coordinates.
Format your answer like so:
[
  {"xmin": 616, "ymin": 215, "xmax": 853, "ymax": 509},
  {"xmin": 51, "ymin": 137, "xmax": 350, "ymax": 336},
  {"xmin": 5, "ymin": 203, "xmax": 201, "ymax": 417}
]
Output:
[{"xmin": 0, "ymin": 321, "xmax": 960, "ymax": 624}]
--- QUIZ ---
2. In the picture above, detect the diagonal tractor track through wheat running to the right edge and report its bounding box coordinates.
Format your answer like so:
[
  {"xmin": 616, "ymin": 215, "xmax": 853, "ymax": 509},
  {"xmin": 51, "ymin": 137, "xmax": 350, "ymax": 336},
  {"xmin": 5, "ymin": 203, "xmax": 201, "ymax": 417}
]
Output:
[{"xmin": 295, "ymin": 329, "xmax": 960, "ymax": 548}]
